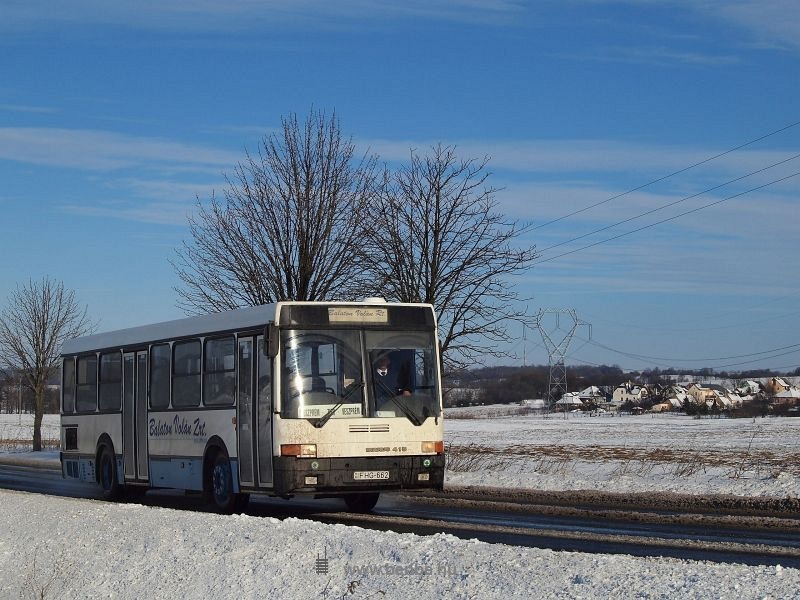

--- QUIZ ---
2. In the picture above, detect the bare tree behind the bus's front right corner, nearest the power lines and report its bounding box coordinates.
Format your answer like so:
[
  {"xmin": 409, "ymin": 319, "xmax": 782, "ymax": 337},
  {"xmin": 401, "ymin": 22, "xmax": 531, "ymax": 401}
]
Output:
[{"xmin": 366, "ymin": 144, "xmax": 536, "ymax": 368}]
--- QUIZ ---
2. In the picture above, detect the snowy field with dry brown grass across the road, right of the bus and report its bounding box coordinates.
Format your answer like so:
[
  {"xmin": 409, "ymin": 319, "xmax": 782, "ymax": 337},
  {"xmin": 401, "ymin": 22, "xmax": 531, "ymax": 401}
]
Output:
[{"xmin": 445, "ymin": 406, "xmax": 800, "ymax": 497}]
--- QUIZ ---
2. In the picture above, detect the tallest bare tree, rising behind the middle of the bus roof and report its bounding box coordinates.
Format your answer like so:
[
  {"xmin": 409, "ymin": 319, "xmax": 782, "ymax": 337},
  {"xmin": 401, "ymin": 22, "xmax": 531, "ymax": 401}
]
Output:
[{"xmin": 173, "ymin": 110, "xmax": 377, "ymax": 314}]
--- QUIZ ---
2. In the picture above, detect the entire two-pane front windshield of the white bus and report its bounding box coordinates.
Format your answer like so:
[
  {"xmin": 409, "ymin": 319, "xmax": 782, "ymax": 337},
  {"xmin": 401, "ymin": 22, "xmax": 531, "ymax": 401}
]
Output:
[{"xmin": 281, "ymin": 329, "xmax": 441, "ymax": 427}]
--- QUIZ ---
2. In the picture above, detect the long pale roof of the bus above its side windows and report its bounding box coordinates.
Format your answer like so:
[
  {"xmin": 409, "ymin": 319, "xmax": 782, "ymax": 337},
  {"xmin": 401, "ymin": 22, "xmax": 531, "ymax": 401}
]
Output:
[{"xmin": 61, "ymin": 304, "xmax": 277, "ymax": 355}]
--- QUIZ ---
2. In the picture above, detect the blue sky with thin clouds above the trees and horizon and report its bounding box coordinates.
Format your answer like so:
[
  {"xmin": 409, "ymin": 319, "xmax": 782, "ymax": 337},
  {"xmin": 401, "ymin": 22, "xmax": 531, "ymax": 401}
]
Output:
[{"xmin": 0, "ymin": 0, "xmax": 800, "ymax": 370}]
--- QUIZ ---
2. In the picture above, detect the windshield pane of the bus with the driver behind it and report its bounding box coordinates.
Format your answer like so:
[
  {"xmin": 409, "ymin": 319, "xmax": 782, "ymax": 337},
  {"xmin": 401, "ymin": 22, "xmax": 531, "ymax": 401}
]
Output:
[{"xmin": 365, "ymin": 331, "xmax": 441, "ymax": 425}]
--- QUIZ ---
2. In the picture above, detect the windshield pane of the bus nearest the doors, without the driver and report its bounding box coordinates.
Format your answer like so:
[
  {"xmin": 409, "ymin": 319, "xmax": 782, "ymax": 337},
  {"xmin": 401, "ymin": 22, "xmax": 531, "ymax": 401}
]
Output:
[{"xmin": 281, "ymin": 330, "xmax": 364, "ymax": 420}]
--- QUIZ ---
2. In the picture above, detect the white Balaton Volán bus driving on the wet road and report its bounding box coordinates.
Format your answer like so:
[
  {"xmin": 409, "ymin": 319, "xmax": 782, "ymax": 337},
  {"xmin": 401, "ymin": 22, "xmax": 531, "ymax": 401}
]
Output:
[{"xmin": 61, "ymin": 299, "xmax": 444, "ymax": 512}]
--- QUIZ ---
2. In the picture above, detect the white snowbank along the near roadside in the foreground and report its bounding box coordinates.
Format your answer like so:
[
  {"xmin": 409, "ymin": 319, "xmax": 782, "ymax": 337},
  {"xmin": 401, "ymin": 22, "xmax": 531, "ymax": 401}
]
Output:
[{"xmin": 0, "ymin": 490, "xmax": 800, "ymax": 599}]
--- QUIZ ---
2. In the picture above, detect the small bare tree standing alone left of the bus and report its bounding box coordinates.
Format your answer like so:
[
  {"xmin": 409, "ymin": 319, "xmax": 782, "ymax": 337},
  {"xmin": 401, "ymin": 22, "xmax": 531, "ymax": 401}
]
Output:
[{"xmin": 0, "ymin": 277, "xmax": 94, "ymax": 451}]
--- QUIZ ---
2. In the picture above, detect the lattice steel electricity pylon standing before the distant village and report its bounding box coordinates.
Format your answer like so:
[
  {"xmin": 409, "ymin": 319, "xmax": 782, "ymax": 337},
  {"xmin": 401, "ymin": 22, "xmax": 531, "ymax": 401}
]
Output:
[{"xmin": 534, "ymin": 308, "xmax": 592, "ymax": 406}]
